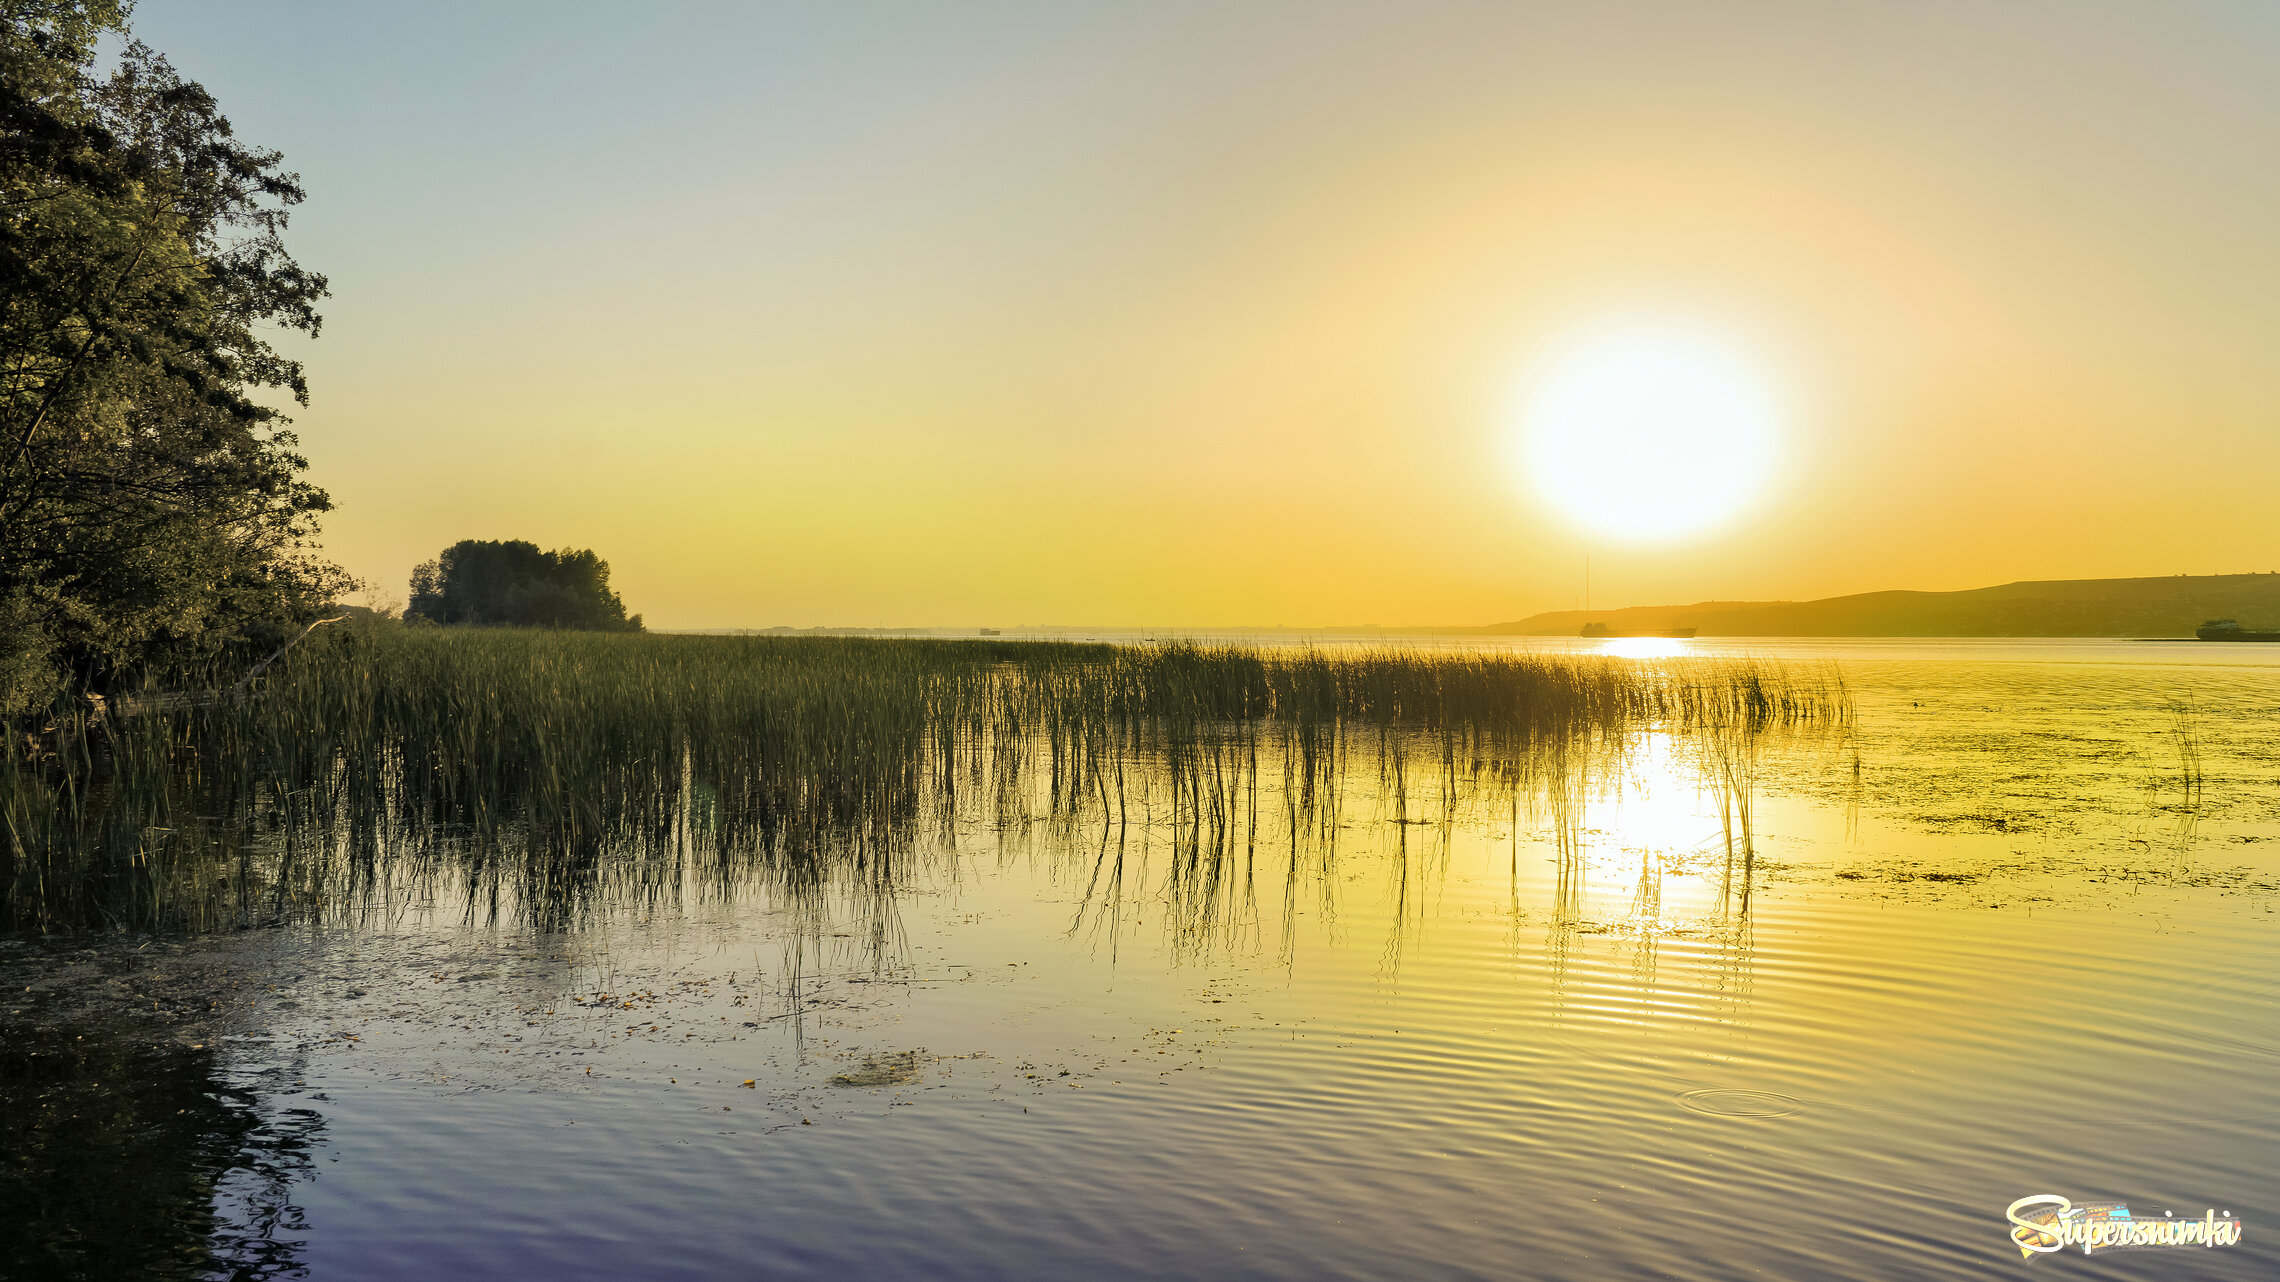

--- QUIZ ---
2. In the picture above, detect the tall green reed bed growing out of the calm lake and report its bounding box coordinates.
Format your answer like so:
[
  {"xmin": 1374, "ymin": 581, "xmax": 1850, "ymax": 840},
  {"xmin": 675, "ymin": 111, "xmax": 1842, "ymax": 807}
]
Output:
[{"xmin": 0, "ymin": 623, "xmax": 1849, "ymax": 931}]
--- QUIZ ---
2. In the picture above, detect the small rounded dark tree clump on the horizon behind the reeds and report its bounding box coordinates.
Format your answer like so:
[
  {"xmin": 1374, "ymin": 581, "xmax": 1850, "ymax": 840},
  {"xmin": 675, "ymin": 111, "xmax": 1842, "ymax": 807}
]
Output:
[{"xmin": 404, "ymin": 538, "xmax": 641, "ymax": 632}]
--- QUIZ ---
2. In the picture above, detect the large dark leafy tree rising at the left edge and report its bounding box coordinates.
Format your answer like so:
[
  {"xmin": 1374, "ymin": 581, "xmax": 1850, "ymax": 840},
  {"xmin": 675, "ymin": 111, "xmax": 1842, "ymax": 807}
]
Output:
[{"xmin": 0, "ymin": 0, "xmax": 347, "ymax": 703}]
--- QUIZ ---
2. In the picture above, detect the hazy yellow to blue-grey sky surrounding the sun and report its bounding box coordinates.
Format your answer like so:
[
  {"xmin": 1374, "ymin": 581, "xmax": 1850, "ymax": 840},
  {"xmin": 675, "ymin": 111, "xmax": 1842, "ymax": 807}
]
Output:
[{"xmin": 139, "ymin": 0, "xmax": 2280, "ymax": 627}]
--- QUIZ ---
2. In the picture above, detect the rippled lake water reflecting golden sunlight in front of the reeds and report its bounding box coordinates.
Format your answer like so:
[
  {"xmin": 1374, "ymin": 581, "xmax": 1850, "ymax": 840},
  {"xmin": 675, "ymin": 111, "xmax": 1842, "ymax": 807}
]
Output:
[{"xmin": 0, "ymin": 641, "xmax": 2280, "ymax": 1280}]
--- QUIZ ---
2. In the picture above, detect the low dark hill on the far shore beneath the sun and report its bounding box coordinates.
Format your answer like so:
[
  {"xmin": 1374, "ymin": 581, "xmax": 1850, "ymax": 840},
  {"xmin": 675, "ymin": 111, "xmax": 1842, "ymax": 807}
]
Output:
[{"xmin": 1484, "ymin": 575, "xmax": 2280, "ymax": 636}]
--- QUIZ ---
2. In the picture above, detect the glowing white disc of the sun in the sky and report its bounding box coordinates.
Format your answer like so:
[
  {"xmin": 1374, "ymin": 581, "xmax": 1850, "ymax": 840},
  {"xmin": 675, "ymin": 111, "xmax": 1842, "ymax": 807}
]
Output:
[{"xmin": 1516, "ymin": 322, "xmax": 1783, "ymax": 541}]
